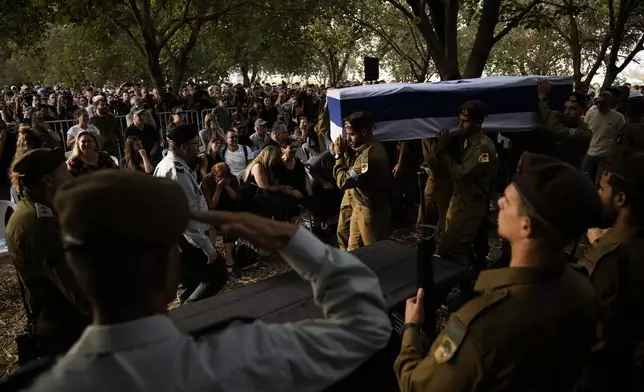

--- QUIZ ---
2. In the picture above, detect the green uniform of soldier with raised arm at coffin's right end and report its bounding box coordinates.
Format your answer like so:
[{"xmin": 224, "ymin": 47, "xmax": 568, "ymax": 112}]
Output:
[{"xmin": 539, "ymin": 101, "xmax": 592, "ymax": 168}]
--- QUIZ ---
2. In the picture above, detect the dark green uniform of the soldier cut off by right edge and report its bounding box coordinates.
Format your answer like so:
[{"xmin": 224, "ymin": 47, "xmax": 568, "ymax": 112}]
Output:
[{"xmin": 576, "ymin": 228, "xmax": 644, "ymax": 391}]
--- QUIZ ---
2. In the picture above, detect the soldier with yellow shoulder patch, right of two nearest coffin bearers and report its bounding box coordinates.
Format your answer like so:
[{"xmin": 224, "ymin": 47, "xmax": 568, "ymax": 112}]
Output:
[{"xmin": 438, "ymin": 101, "xmax": 496, "ymax": 265}]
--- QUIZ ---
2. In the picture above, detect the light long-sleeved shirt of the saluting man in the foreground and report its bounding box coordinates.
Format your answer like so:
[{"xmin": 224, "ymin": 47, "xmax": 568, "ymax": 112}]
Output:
[{"xmin": 30, "ymin": 229, "xmax": 391, "ymax": 392}]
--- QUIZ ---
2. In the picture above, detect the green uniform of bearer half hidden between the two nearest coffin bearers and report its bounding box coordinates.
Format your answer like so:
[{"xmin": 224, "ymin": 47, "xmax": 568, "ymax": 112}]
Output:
[{"xmin": 416, "ymin": 138, "xmax": 453, "ymax": 231}]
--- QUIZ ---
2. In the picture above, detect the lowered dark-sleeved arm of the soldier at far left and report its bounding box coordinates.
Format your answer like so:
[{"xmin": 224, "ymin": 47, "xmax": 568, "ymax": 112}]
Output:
[{"xmin": 26, "ymin": 218, "xmax": 91, "ymax": 315}]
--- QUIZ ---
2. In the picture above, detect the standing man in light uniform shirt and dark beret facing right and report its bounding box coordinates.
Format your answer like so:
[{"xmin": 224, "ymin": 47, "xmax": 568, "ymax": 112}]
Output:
[{"xmin": 154, "ymin": 124, "xmax": 228, "ymax": 303}]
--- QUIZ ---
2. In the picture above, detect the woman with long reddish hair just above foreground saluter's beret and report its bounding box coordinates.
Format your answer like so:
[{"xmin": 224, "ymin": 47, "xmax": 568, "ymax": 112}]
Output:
[{"xmin": 67, "ymin": 131, "xmax": 118, "ymax": 177}]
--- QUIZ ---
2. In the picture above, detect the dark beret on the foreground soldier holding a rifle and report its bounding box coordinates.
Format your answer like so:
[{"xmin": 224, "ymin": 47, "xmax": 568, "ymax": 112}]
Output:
[{"xmin": 513, "ymin": 152, "xmax": 604, "ymax": 238}]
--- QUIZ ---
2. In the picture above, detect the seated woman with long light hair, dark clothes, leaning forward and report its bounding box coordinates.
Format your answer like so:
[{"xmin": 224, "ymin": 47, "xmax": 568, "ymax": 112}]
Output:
[{"xmin": 242, "ymin": 146, "xmax": 300, "ymax": 220}]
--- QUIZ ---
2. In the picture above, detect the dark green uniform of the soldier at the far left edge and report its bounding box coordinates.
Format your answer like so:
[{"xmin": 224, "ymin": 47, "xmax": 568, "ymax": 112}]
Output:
[{"xmin": 6, "ymin": 198, "xmax": 91, "ymax": 355}]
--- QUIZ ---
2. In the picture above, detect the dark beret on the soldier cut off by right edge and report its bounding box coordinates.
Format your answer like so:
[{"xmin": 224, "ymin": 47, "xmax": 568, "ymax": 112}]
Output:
[{"xmin": 608, "ymin": 146, "xmax": 644, "ymax": 197}]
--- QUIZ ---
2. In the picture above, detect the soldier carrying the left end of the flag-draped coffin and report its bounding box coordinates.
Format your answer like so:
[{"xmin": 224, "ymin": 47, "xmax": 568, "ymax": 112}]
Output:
[{"xmin": 333, "ymin": 112, "xmax": 391, "ymax": 251}]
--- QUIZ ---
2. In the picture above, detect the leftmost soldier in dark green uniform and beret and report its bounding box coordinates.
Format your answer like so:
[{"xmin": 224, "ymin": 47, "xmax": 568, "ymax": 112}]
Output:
[{"xmin": 6, "ymin": 148, "xmax": 90, "ymax": 356}]
